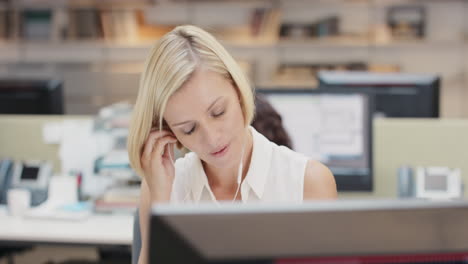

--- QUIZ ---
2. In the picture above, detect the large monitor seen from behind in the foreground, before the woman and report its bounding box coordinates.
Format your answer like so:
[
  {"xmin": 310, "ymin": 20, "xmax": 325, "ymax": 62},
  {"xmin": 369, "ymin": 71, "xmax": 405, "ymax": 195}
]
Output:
[{"xmin": 149, "ymin": 200, "xmax": 468, "ymax": 264}]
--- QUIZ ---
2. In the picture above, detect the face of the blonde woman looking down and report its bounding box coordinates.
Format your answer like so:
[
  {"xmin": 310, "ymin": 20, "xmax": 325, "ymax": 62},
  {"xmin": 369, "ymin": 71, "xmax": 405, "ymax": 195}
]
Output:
[{"xmin": 164, "ymin": 69, "xmax": 246, "ymax": 168}]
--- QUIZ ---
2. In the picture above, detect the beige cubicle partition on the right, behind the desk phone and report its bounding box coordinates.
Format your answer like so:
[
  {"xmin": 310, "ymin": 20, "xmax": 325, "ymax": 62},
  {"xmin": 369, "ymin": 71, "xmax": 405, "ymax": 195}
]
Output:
[{"xmin": 339, "ymin": 118, "xmax": 468, "ymax": 198}]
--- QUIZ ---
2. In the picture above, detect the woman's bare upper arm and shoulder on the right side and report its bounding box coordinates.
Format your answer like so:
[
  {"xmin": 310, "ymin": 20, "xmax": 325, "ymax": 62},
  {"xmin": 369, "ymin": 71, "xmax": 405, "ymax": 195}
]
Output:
[{"xmin": 304, "ymin": 160, "xmax": 338, "ymax": 200}]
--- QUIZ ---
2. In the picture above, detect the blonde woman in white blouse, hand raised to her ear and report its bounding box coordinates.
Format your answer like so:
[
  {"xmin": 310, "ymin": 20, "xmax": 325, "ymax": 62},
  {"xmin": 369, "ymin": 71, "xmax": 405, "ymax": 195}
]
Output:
[{"xmin": 128, "ymin": 26, "xmax": 337, "ymax": 263}]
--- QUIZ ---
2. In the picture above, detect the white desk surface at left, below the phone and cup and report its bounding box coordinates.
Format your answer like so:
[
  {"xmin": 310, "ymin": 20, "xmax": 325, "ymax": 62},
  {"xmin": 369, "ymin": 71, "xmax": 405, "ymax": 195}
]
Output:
[{"xmin": 0, "ymin": 207, "xmax": 133, "ymax": 246}]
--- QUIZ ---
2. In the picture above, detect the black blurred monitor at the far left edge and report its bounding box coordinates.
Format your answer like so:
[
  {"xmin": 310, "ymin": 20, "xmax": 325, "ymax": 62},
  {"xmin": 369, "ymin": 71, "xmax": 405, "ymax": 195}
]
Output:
[{"xmin": 0, "ymin": 79, "xmax": 64, "ymax": 115}]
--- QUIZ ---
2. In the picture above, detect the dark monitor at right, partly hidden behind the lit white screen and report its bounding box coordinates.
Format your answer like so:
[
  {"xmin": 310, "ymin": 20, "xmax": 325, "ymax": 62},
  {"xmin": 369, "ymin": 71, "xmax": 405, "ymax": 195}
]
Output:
[{"xmin": 318, "ymin": 71, "xmax": 440, "ymax": 118}]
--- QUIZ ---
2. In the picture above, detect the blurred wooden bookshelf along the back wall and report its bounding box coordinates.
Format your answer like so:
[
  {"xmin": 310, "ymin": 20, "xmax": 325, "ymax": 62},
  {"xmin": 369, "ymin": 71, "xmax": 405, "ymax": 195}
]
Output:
[{"xmin": 0, "ymin": 0, "xmax": 468, "ymax": 117}]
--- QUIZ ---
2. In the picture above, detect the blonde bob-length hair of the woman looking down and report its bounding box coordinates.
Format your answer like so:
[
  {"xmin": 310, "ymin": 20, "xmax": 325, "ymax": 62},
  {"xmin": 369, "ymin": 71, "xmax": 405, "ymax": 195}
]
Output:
[{"xmin": 127, "ymin": 25, "xmax": 255, "ymax": 176}]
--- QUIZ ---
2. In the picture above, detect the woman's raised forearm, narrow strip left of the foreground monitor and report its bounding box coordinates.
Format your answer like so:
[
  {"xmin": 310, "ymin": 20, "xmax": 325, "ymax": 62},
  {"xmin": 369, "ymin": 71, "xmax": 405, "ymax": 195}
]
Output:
[{"xmin": 138, "ymin": 178, "xmax": 151, "ymax": 264}]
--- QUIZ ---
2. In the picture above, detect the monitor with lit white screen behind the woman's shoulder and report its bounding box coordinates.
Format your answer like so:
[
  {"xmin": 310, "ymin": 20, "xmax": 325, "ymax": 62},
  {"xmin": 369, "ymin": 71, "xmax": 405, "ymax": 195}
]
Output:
[{"xmin": 257, "ymin": 88, "xmax": 373, "ymax": 191}]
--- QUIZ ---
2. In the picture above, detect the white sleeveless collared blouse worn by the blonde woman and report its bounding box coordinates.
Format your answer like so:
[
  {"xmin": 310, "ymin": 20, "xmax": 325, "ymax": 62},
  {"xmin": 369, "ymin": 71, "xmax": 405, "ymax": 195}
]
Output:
[{"xmin": 171, "ymin": 127, "xmax": 308, "ymax": 203}]
